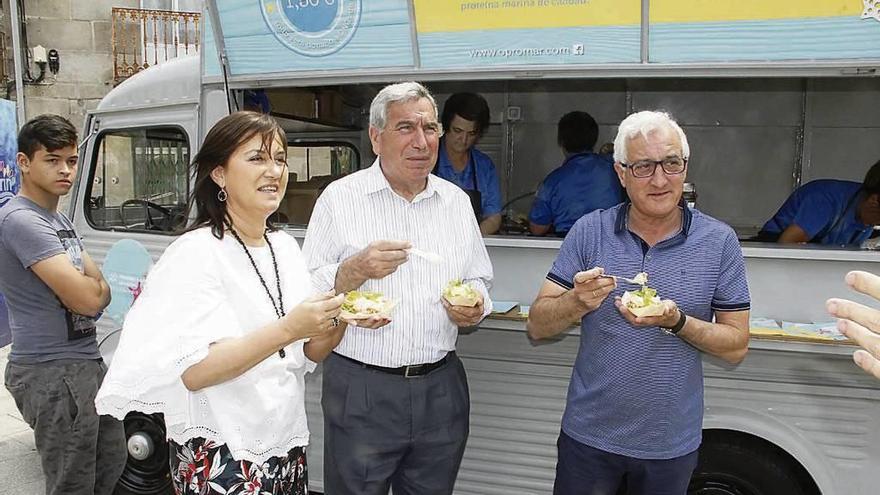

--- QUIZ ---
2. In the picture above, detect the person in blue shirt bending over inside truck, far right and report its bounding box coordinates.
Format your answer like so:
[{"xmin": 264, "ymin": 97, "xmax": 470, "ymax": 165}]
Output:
[{"xmin": 757, "ymin": 160, "xmax": 880, "ymax": 246}]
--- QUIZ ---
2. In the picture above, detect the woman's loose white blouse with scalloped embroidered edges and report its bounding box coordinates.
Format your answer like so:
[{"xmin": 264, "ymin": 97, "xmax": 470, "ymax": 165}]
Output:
[{"xmin": 95, "ymin": 228, "xmax": 315, "ymax": 463}]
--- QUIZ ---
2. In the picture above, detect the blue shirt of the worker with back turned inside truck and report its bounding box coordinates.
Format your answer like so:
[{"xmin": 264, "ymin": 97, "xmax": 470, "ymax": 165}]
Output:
[{"xmin": 529, "ymin": 152, "xmax": 624, "ymax": 233}]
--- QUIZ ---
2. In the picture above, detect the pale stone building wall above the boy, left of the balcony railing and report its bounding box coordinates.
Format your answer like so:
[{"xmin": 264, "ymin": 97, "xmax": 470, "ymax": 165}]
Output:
[{"xmin": 2, "ymin": 0, "xmax": 140, "ymax": 130}]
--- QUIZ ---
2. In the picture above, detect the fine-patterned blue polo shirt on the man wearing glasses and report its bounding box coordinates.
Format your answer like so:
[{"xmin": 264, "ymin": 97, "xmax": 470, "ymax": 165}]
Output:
[{"xmin": 547, "ymin": 203, "xmax": 750, "ymax": 459}]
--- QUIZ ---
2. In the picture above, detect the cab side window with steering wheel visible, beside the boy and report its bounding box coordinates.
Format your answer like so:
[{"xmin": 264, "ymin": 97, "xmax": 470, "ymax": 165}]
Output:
[{"xmin": 85, "ymin": 126, "xmax": 190, "ymax": 233}]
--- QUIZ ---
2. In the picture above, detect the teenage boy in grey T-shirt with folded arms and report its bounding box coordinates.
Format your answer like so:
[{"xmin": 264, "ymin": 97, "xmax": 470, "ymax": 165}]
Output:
[{"xmin": 0, "ymin": 115, "xmax": 126, "ymax": 495}]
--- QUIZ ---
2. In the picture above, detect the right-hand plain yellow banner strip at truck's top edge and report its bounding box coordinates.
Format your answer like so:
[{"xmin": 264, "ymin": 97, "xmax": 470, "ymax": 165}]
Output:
[{"xmin": 650, "ymin": 0, "xmax": 863, "ymax": 23}]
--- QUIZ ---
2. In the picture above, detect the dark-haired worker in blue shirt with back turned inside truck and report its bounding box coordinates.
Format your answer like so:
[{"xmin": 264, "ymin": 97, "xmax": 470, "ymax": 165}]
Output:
[{"xmin": 529, "ymin": 111, "xmax": 623, "ymax": 236}]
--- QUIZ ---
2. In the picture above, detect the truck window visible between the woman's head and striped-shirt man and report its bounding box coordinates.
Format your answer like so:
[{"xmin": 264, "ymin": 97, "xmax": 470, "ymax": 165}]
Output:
[{"xmin": 273, "ymin": 143, "xmax": 360, "ymax": 226}]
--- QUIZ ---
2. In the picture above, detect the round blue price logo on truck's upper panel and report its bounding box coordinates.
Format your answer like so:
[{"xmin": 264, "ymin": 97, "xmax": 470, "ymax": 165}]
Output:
[{"xmin": 260, "ymin": 0, "xmax": 362, "ymax": 57}]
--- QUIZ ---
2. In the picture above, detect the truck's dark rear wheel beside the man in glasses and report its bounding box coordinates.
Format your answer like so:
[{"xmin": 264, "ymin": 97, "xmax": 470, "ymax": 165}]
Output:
[{"xmin": 688, "ymin": 437, "xmax": 818, "ymax": 495}]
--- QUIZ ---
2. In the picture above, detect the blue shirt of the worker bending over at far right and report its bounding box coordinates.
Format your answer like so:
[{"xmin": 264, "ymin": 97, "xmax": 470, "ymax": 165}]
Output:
[{"xmin": 761, "ymin": 179, "xmax": 873, "ymax": 245}]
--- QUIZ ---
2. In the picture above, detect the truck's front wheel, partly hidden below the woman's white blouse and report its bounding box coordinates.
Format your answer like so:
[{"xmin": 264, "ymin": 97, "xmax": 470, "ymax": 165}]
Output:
[{"xmin": 115, "ymin": 412, "xmax": 174, "ymax": 495}]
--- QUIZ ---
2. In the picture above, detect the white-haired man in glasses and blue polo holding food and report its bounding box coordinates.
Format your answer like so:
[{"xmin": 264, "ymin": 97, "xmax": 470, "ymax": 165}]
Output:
[{"xmin": 528, "ymin": 112, "xmax": 750, "ymax": 495}]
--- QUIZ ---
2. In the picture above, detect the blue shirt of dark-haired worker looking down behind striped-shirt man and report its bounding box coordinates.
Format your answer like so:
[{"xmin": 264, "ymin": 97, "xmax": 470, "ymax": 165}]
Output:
[{"xmin": 437, "ymin": 142, "xmax": 501, "ymax": 218}]
